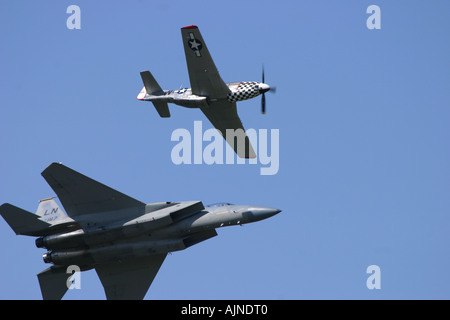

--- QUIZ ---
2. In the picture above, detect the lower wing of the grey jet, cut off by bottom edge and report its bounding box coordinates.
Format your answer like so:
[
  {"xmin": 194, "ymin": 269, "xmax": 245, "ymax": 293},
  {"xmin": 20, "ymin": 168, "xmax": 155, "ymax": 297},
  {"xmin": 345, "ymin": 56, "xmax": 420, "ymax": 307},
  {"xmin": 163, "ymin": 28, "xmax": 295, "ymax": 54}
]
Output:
[{"xmin": 95, "ymin": 254, "xmax": 166, "ymax": 300}]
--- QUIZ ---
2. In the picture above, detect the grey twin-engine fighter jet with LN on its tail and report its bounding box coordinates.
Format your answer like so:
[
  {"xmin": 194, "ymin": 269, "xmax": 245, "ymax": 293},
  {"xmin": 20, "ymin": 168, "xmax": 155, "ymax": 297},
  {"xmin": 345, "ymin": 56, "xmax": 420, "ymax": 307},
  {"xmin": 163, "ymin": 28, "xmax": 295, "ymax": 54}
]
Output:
[{"xmin": 0, "ymin": 163, "xmax": 280, "ymax": 299}]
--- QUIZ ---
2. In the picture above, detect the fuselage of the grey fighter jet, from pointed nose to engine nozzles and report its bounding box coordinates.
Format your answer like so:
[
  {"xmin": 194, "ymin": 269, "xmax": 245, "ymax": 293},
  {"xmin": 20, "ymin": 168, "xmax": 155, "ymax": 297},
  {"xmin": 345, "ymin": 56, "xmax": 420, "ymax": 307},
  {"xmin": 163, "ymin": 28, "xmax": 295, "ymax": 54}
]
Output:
[{"xmin": 36, "ymin": 202, "xmax": 280, "ymax": 270}]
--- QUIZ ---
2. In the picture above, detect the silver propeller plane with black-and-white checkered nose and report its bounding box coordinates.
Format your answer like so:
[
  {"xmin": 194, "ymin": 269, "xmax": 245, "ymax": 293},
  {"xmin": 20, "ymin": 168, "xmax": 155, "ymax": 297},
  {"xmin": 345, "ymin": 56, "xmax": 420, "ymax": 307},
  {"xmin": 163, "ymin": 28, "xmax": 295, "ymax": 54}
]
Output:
[{"xmin": 137, "ymin": 25, "xmax": 274, "ymax": 158}]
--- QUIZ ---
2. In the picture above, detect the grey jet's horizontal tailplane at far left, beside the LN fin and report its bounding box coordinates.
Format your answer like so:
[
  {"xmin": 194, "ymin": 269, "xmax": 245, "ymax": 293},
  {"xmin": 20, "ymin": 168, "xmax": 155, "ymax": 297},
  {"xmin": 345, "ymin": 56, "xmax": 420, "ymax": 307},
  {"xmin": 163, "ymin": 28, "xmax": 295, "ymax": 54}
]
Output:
[{"xmin": 0, "ymin": 203, "xmax": 51, "ymax": 237}]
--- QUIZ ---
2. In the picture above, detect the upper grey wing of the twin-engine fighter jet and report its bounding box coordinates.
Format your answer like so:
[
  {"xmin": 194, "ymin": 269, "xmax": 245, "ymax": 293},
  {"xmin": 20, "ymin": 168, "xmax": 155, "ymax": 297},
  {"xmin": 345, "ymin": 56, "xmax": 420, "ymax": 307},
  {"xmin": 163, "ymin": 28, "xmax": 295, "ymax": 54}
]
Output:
[{"xmin": 41, "ymin": 163, "xmax": 145, "ymax": 218}]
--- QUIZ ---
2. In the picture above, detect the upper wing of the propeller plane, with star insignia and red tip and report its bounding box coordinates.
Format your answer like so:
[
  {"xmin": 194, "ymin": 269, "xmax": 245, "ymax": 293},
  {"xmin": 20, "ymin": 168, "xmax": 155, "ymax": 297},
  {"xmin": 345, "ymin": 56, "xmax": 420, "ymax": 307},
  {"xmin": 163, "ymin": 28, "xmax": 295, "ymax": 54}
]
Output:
[{"xmin": 181, "ymin": 26, "xmax": 230, "ymax": 100}]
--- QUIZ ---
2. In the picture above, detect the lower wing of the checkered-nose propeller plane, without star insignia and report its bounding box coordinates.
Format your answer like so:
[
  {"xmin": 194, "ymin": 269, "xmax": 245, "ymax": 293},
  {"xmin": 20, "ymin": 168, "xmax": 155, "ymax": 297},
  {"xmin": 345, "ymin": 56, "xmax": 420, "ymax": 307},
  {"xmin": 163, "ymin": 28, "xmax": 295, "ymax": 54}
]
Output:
[{"xmin": 200, "ymin": 101, "xmax": 256, "ymax": 158}]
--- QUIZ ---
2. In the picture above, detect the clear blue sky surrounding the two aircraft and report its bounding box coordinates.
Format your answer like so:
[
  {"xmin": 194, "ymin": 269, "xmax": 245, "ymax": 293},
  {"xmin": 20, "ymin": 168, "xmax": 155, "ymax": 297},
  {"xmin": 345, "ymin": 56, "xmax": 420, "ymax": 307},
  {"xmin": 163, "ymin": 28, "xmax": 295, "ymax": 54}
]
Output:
[{"xmin": 0, "ymin": 0, "xmax": 450, "ymax": 299}]
